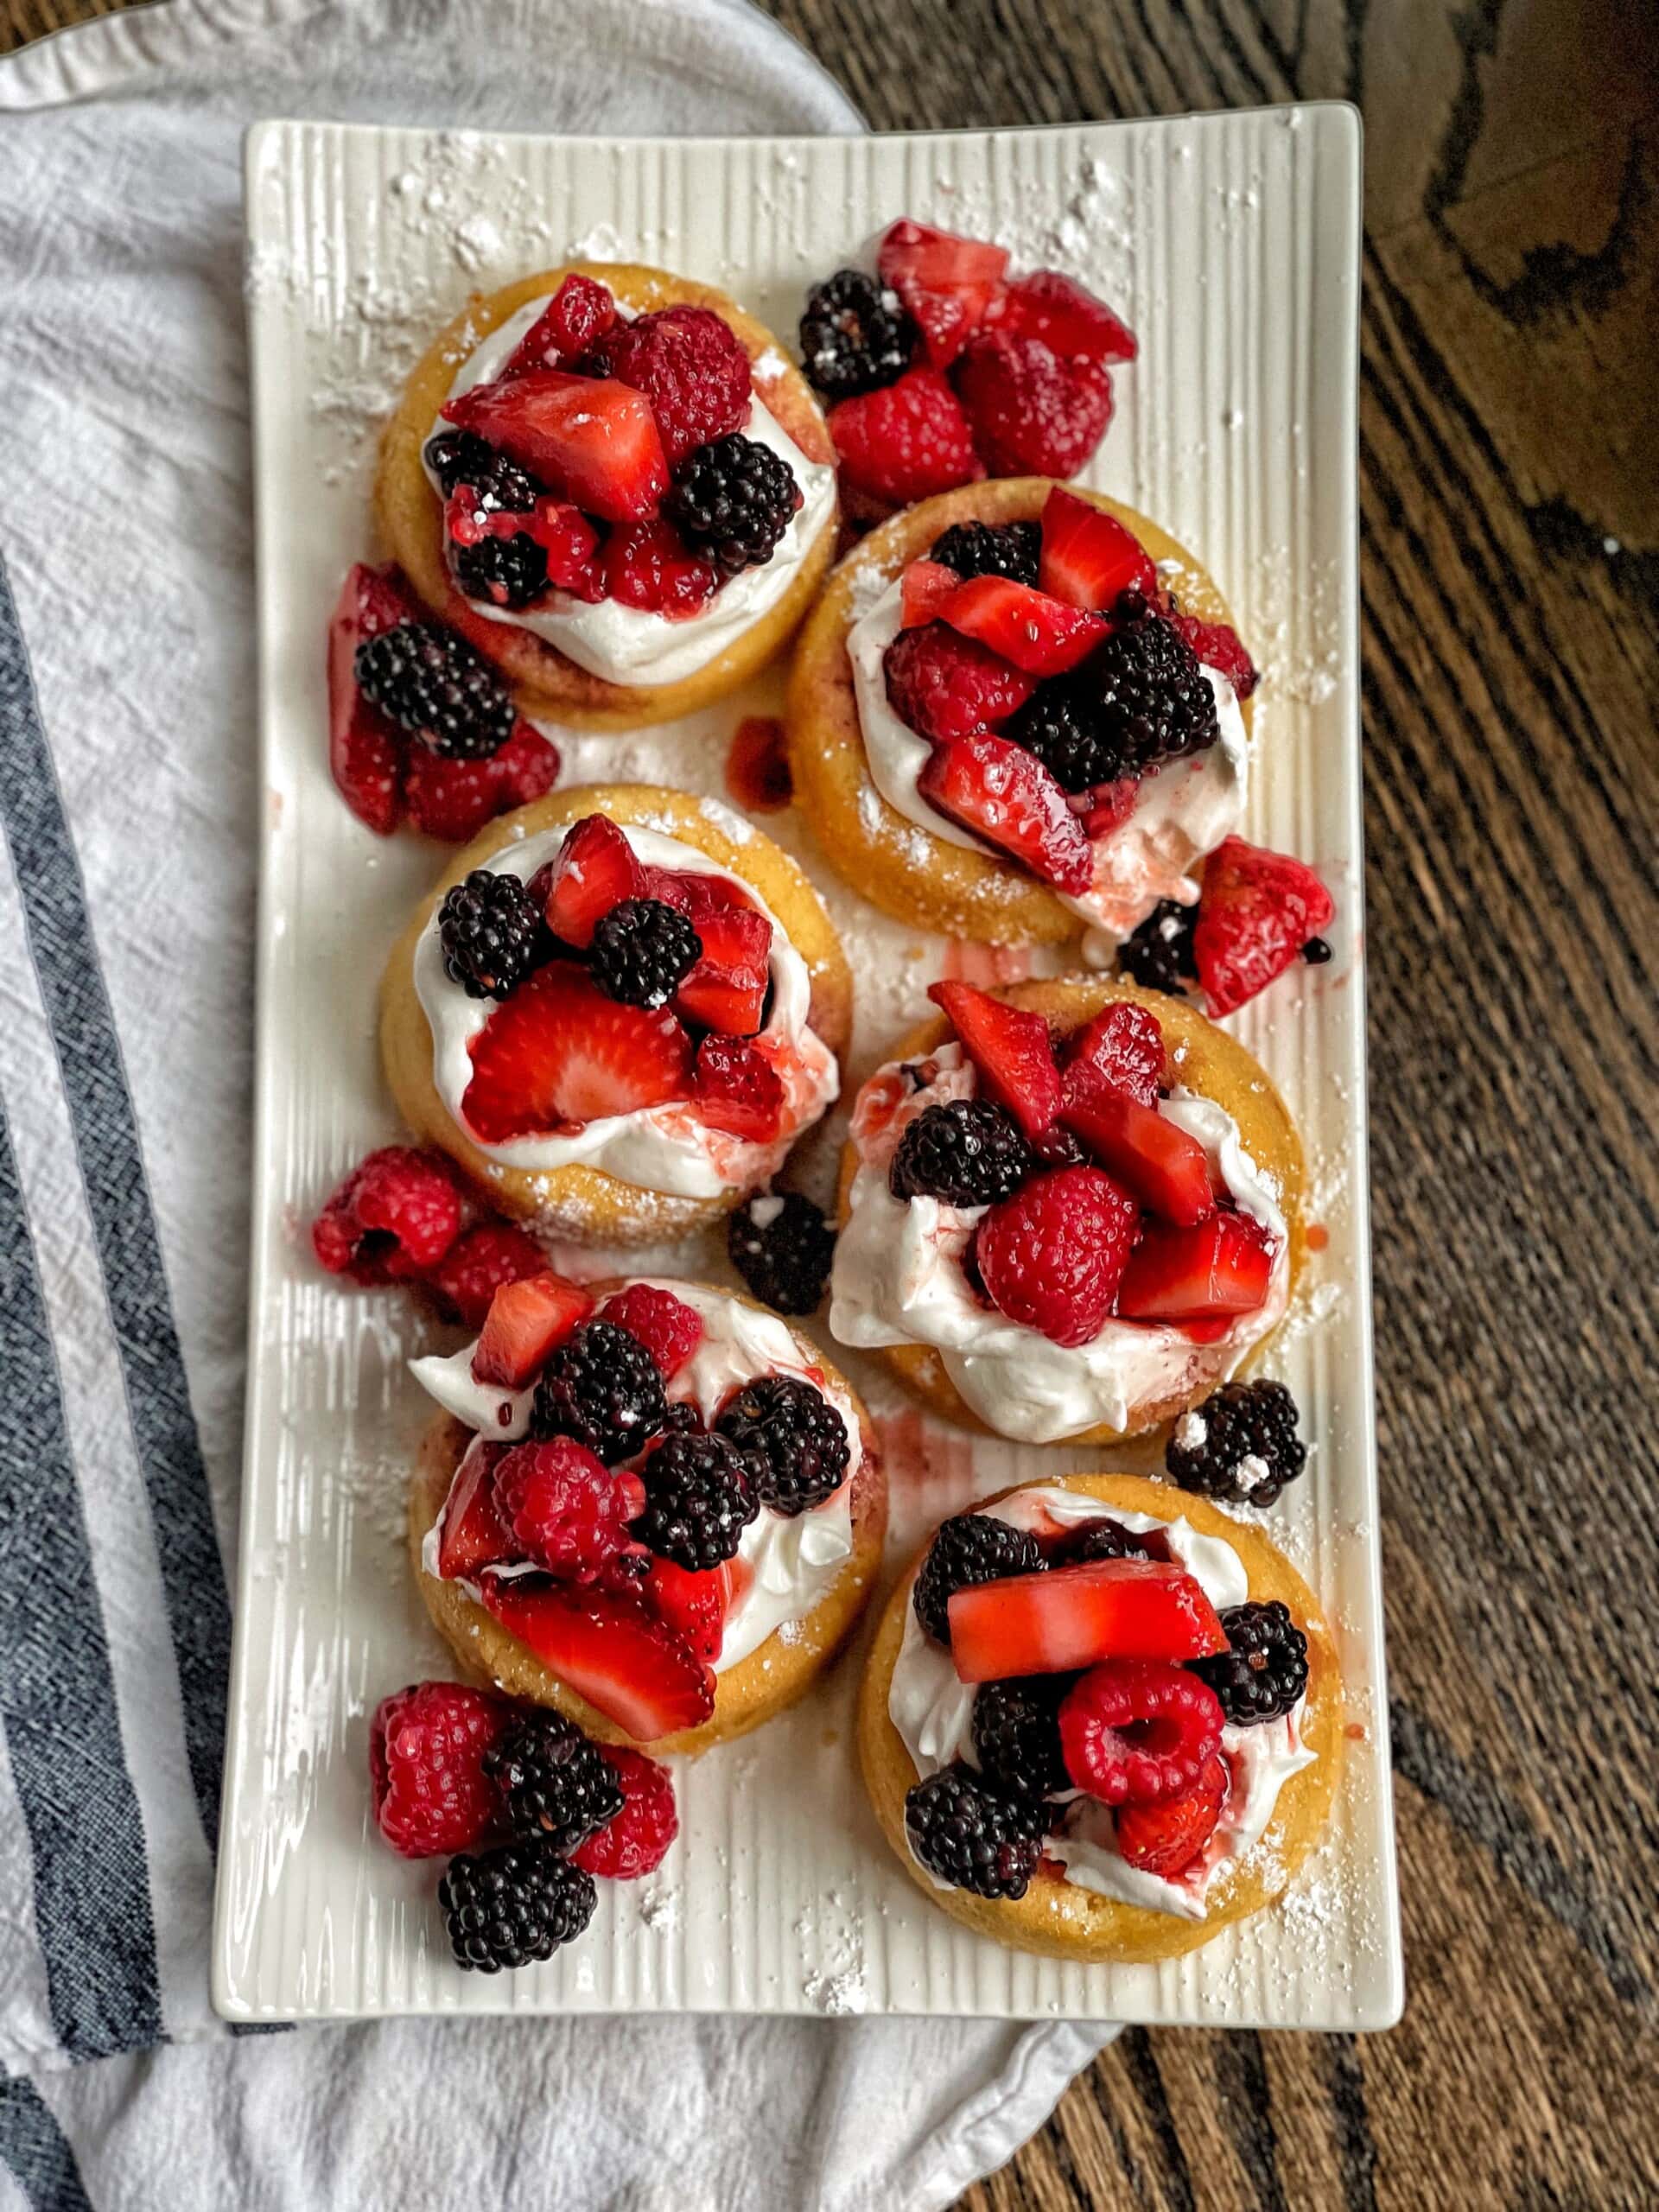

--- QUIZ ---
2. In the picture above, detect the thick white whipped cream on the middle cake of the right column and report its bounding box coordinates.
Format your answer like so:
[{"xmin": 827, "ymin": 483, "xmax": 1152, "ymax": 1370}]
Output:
[{"xmin": 830, "ymin": 1042, "xmax": 1289, "ymax": 1445}]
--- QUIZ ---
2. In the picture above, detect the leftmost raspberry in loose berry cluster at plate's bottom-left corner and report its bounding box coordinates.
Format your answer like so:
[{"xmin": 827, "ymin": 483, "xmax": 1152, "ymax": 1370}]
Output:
[{"xmin": 370, "ymin": 1681, "xmax": 513, "ymax": 1858}]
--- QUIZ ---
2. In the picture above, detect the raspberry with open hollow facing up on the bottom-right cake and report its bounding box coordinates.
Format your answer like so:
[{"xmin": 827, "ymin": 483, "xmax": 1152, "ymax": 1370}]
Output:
[{"xmin": 1059, "ymin": 1659, "xmax": 1221, "ymax": 1805}]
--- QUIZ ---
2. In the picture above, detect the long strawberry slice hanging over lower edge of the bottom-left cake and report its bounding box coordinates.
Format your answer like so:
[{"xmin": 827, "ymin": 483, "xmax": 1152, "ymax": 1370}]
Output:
[{"xmin": 482, "ymin": 1575, "xmax": 715, "ymax": 1743}]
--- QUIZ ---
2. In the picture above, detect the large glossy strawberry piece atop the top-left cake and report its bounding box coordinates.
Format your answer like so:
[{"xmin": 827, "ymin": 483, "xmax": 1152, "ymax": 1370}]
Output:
[{"xmin": 442, "ymin": 370, "xmax": 668, "ymax": 522}]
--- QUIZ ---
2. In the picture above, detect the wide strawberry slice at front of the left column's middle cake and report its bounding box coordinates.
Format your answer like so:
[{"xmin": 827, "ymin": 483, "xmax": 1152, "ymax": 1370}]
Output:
[{"xmin": 460, "ymin": 960, "xmax": 692, "ymax": 1144}]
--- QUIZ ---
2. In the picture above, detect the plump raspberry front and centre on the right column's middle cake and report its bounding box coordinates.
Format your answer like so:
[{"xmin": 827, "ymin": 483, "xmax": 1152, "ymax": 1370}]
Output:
[{"xmin": 973, "ymin": 1168, "xmax": 1141, "ymax": 1344}]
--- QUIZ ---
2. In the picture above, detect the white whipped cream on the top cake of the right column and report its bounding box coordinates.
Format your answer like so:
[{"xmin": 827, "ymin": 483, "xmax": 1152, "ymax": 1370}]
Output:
[{"xmin": 847, "ymin": 580, "xmax": 1249, "ymax": 944}]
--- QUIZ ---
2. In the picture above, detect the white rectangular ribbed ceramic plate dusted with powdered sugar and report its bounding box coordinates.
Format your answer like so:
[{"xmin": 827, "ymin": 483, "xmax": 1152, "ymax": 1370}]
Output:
[{"xmin": 214, "ymin": 106, "xmax": 1400, "ymax": 2029}]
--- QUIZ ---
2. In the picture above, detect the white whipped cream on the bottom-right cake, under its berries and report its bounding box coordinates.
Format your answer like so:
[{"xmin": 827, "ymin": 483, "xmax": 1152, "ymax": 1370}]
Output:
[{"xmin": 887, "ymin": 1484, "xmax": 1319, "ymax": 1920}]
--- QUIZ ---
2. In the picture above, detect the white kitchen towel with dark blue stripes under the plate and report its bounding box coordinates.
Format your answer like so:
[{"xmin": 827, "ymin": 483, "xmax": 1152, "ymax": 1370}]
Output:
[{"xmin": 0, "ymin": 0, "xmax": 1106, "ymax": 2212}]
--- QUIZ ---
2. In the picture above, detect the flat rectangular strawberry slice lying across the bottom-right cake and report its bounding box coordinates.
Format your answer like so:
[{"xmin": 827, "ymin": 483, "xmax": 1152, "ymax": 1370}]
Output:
[{"xmin": 949, "ymin": 1560, "xmax": 1228, "ymax": 1681}]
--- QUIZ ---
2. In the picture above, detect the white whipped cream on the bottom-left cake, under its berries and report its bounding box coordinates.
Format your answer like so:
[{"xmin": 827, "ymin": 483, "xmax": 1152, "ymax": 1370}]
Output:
[{"xmin": 410, "ymin": 1276, "xmax": 865, "ymax": 1675}]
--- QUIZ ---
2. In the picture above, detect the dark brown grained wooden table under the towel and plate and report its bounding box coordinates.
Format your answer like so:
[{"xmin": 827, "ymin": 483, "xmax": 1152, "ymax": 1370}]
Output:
[{"xmin": 0, "ymin": 0, "xmax": 1659, "ymax": 2212}]
